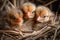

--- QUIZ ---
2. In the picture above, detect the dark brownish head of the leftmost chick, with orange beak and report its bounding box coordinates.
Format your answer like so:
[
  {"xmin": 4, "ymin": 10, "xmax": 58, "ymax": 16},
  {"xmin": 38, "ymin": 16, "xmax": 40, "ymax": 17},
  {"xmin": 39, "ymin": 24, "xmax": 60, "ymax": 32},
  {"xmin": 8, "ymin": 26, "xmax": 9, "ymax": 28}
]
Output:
[{"xmin": 6, "ymin": 9, "xmax": 23, "ymax": 26}]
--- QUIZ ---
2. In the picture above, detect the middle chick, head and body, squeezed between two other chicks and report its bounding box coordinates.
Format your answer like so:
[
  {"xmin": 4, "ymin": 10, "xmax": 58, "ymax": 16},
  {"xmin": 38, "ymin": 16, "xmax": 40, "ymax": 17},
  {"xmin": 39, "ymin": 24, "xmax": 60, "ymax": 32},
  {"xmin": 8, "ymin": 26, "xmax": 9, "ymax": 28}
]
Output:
[{"xmin": 21, "ymin": 2, "xmax": 36, "ymax": 31}]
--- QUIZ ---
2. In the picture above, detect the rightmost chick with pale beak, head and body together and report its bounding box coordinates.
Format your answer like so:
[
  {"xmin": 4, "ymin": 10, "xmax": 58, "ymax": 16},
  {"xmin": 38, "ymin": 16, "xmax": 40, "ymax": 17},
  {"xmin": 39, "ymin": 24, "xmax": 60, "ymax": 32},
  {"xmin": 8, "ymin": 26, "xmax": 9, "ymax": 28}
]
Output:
[{"xmin": 33, "ymin": 6, "xmax": 54, "ymax": 30}]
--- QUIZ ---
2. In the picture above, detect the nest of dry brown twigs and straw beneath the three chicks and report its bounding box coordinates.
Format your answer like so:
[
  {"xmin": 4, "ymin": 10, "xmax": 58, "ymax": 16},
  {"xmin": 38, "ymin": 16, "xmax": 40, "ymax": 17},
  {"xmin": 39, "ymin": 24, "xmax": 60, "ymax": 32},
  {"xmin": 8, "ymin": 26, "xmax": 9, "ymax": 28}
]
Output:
[{"xmin": 0, "ymin": 0, "xmax": 60, "ymax": 40}]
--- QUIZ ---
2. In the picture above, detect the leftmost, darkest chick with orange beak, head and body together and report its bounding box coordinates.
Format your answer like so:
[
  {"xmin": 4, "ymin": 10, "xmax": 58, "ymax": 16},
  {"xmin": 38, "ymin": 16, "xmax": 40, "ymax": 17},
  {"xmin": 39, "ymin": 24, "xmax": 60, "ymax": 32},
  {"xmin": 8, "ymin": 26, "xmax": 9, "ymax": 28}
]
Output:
[{"xmin": 5, "ymin": 8, "xmax": 23, "ymax": 35}]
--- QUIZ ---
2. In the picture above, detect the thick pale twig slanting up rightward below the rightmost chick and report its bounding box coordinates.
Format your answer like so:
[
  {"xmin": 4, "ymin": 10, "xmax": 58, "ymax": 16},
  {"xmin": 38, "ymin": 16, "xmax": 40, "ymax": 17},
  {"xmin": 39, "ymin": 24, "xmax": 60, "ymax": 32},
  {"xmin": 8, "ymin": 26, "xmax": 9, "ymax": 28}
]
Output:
[{"xmin": 19, "ymin": 27, "xmax": 51, "ymax": 39}]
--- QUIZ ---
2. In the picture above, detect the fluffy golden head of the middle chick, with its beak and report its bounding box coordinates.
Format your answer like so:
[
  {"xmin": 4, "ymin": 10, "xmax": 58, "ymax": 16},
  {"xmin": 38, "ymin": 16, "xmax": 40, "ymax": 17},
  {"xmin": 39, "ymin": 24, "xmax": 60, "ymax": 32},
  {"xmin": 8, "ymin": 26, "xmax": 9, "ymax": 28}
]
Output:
[{"xmin": 21, "ymin": 2, "xmax": 36, "ymax": 19}]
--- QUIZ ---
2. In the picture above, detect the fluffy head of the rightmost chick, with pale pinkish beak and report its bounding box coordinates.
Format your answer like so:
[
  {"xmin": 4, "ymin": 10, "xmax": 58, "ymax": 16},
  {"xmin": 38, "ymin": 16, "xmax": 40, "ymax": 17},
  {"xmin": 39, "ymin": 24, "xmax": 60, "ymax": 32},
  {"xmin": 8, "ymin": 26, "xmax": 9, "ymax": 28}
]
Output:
[{"xmin": 36, "ymin": 6, "xmax": 54, "ymax": 23}]
